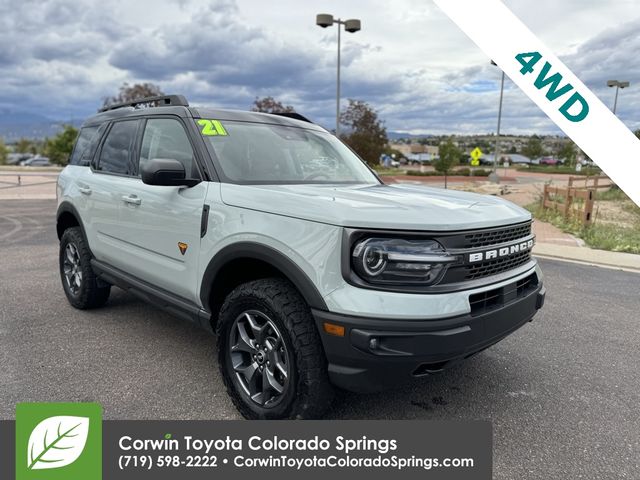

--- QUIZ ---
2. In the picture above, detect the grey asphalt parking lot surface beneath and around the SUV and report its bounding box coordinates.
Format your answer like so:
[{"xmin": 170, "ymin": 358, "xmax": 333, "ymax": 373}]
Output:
[{"xmin": 0, "ymin": 200, "xmax": 640, "ymax": 479}]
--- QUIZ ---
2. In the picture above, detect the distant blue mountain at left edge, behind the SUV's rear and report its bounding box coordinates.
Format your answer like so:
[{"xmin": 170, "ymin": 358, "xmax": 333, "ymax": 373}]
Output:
[{"xmin": 0, "ymin": 110, "xmax": 82, "ymax": 143}]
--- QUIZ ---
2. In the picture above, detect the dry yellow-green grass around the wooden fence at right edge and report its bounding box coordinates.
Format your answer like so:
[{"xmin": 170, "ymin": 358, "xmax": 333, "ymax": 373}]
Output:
[{"xmin": 526, "ymin": 193, "xmax": 640, "ymax": 254}]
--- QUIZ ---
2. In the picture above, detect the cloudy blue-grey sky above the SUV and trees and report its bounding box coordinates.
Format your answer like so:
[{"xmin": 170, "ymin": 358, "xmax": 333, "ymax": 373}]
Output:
[{"xmin": 0, "ymin": 0, "xmax": 640, "ymax": 134}]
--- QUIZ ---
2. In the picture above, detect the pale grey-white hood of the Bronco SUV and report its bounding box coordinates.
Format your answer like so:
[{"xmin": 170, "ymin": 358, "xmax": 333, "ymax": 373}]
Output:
[{"xmin": 221, "ymin": 183, "xmax": 531, "ymax": 231}]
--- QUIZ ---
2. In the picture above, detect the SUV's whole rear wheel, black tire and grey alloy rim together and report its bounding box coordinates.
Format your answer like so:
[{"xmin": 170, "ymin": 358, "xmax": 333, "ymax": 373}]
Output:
[{"xmin": 59, "ymin": 227, "xmax": 111, "ymax": 309}]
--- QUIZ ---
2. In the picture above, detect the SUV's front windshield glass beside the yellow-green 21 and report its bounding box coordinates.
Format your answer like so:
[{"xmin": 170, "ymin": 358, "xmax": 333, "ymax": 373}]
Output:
[{"xmin": 203, "ymin": 121, "xmax": 380, "ymax": 184}]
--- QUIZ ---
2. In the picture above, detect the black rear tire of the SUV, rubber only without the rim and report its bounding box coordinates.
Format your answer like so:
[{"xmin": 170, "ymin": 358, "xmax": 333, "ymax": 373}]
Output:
[{"xmin": 59, "ymin": 227, "xmax": 111, "ymax": 310}]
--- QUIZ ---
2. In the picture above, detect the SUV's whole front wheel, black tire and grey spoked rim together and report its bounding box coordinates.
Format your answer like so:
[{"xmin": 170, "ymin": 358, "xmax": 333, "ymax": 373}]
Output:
[{"xmin": 217, "ymin": 278, "xmax": 333, "ymax": 419}]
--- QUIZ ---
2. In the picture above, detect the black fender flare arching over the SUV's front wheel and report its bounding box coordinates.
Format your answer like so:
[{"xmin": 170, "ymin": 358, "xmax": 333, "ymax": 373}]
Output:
[{"xmin": 200, "ymin": 242, "xmax": 328, "ymax": 311}]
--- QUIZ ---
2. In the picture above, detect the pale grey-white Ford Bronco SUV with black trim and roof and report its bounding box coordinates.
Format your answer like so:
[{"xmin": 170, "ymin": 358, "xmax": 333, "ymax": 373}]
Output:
[{"xmin": 57, "ymin": 95, "xmax": 544, "ymax": 419}]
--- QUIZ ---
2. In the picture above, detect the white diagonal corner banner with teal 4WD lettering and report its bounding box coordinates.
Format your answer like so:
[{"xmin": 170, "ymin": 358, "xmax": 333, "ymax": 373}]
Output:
[{"xmin": 435, "ymin": 0, "xmax": 640, "ymax": 205}]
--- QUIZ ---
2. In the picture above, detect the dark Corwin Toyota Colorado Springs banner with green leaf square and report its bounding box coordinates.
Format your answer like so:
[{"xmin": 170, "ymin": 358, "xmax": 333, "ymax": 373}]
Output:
[{"xmin": 0, "ymin": 404, "xmax": 492, "ymax": 480}]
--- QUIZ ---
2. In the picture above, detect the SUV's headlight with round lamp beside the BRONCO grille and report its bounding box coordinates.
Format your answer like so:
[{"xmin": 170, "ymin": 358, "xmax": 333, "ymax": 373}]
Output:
[{"xmin": 351, "ymin": 238, "xmax": 459, "ymax": 286}]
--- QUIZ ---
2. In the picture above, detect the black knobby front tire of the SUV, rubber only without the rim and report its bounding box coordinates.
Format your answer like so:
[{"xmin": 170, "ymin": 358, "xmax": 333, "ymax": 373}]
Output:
[{"xmin": 217, "ymin": 278, "xmax": 333, "ymax": 420}]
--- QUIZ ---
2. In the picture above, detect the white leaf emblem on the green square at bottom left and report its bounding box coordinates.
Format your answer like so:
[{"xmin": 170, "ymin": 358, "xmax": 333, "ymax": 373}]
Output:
[{"xmin": 27, "ymin": 416, "xmax": 89, "ymax": 470}]
